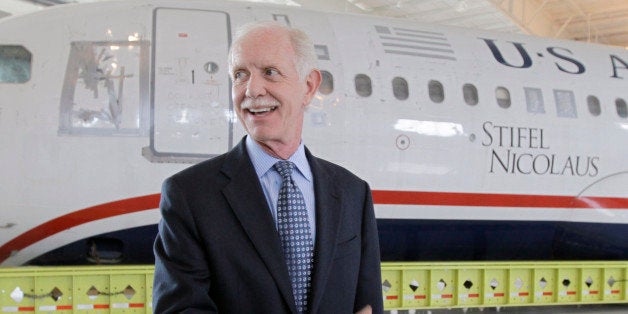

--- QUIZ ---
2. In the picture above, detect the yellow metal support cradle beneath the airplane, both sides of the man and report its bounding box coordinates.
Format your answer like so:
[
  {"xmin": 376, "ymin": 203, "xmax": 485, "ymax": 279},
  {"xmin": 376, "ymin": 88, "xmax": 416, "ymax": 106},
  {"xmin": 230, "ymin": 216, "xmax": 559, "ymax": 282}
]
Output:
[{"xmin": 0, "ymin": 261, "xmax": 628, "ymax": 313}]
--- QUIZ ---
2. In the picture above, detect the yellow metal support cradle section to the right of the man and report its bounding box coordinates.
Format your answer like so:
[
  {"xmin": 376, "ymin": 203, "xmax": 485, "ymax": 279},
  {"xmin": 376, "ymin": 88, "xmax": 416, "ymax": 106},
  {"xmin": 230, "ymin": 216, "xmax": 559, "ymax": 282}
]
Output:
[{"xmin": 382, "ymin": 261, "xmax": 628, "ymax": 310}]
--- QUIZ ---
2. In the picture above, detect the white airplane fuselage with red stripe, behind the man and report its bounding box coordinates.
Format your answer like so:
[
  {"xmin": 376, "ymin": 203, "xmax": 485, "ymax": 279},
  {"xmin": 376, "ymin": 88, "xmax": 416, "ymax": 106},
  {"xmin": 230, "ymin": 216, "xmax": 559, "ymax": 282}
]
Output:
[{"xmin": 0, "ymin": 0, "xmax": 628, "ymax": 265}]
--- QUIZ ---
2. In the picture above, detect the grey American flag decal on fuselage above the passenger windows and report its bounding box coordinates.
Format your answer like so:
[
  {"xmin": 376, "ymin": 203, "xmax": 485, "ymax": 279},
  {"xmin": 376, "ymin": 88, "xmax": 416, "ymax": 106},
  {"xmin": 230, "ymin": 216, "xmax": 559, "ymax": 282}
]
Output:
[{"xmin": 375, "ymin": 25, "xmax": 456, "ymax": 61}]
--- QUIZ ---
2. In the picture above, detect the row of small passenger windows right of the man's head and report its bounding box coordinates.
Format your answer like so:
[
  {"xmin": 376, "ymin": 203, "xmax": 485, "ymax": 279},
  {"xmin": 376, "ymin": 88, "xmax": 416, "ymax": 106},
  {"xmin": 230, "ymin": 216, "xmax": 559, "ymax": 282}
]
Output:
[{"xmin": 319, "ymin": 71, "xmax": 628, "ymax": 118}]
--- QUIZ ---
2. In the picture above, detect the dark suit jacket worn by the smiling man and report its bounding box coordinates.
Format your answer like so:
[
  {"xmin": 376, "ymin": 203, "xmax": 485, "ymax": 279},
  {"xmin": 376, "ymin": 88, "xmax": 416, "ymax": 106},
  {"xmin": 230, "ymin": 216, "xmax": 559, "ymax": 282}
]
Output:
[{"xmin": 153, "ymin": 140, "xmax": 383, "ymax": 314}]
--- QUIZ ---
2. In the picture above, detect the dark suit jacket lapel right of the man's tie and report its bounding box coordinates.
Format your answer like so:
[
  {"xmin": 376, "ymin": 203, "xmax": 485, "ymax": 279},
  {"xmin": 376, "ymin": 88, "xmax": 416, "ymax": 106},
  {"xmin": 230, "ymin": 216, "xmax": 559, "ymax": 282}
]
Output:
[{"xmin": 306, "ymin": 150, "xmax": 342, "ymax": 313}]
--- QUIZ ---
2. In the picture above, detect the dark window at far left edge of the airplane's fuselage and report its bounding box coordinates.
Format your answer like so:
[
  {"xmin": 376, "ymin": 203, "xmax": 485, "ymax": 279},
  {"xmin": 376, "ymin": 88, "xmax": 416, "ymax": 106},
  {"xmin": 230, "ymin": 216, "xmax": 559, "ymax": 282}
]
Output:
[{"xmin": 0, "ymin": 45, "xmax": 33, "ymax": 83}]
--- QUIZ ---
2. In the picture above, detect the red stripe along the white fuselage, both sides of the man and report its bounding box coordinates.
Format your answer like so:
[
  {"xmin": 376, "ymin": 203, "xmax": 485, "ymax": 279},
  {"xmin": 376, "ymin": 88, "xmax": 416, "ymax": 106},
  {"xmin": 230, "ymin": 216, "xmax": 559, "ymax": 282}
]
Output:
[{"xmin": 0, "ymin": 190, "xmax": 628, "ymax": 263}]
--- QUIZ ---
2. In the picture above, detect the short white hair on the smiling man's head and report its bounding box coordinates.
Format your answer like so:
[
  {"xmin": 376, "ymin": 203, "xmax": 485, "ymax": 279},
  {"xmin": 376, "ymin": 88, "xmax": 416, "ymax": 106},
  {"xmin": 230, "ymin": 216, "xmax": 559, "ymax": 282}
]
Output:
[{"xmin": 228, "ymin": 21, "xmax": 318, "ymax": 80}]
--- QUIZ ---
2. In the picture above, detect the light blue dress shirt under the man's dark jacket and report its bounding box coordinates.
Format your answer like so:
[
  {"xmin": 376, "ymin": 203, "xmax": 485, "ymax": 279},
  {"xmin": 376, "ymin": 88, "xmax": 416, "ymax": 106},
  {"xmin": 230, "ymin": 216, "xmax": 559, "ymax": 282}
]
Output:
[{"xmin": 246, "ymin": 135, "xmax": 316, "ymax": 241}]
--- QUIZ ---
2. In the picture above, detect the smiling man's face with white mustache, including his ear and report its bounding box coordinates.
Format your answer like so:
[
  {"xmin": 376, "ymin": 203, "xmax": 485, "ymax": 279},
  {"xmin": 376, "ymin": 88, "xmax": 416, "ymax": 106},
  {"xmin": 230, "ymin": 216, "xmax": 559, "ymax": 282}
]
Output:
[{"xmin": 231, "ymin": 28, "xmax": 317, "ymax": 152}]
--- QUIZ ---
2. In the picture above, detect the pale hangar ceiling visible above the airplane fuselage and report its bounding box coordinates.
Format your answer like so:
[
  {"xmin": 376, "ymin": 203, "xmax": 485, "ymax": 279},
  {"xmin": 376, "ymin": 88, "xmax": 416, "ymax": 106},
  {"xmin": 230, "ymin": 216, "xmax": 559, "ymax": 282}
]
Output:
[{"xmin": 0, "ymin": 0, "xmax": 628, "ymax": 49}]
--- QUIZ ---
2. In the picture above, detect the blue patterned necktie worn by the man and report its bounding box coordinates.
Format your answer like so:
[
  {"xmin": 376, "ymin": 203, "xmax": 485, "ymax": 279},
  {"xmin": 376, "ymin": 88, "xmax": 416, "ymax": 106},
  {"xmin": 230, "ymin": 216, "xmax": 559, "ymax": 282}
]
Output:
[{"xmin": 275, "ymin": 160, "xmax": 314, "ymax": 313}]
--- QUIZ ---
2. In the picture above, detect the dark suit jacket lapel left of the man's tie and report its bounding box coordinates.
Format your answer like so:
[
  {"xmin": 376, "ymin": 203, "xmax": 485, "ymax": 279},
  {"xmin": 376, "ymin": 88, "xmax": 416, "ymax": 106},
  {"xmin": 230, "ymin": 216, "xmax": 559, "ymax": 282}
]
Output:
[{"xmin": 222, "ymin": 140, "xmax": 296, "ymax": 312}]
